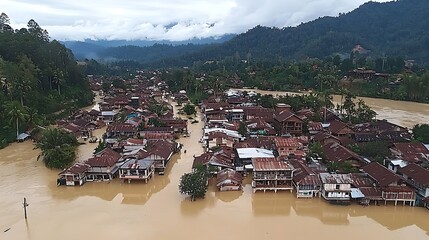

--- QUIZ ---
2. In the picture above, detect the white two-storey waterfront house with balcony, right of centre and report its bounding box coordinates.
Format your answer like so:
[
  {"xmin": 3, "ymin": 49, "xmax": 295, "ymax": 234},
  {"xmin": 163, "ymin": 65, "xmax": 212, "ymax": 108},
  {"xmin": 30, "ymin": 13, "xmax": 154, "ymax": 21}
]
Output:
[{"xmin": 319, "ymin": 173, "xmax": 352, "ymax": 203}]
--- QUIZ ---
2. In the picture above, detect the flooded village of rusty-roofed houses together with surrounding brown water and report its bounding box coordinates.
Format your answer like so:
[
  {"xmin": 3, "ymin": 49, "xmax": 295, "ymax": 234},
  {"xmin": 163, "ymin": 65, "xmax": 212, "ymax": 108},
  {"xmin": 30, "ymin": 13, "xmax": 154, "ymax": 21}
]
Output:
[{"xmin": 0, "ymin": 71, "xmax": 429, "ymax": 239}]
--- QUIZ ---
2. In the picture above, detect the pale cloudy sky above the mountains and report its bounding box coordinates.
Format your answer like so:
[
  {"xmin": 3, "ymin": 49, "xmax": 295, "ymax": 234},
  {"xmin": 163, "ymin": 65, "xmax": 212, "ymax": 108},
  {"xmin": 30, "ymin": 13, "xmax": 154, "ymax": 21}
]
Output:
[{"xmin": 0, "ymin": 0, "xmax": 387, "ymax": 40}]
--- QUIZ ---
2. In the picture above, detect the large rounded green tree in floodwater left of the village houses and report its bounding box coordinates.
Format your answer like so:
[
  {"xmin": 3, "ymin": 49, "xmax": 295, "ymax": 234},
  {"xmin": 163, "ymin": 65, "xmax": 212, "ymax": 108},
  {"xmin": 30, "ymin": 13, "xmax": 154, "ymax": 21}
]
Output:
[{"xmin": 36, "ymin": 128, "xmax": 78, "ymax": 169}]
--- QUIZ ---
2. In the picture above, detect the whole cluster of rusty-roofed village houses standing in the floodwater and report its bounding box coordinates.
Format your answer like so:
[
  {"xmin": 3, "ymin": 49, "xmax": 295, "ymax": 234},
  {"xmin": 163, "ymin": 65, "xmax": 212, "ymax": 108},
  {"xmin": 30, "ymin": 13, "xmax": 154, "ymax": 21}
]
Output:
[{"xmin": 58, "ymin": 71, "xmax": 429, "ymax": 207}]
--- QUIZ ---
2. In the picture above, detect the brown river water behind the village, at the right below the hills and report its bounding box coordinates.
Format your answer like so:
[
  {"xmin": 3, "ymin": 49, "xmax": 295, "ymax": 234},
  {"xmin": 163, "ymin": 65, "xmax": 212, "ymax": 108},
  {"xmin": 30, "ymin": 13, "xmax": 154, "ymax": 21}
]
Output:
[{"xmin": 236, "ymin": 89, "xmax": 429, "ymax": 128}]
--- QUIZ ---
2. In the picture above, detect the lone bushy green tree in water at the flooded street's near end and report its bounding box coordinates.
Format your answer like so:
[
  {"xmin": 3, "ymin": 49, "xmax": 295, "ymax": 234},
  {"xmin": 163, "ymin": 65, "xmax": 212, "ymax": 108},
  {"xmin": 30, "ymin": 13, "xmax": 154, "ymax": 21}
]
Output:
[{"xmin": 179, "ymin": 166, "xmax": 209, "ymax": 201}]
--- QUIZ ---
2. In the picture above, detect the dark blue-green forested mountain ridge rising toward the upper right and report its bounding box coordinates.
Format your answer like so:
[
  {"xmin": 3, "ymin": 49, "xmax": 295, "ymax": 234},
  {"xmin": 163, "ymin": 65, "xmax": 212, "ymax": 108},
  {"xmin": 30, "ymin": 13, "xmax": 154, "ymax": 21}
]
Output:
[{"xmin": 86, "ymin": 0, "xmax": 429, "ymax": 66}]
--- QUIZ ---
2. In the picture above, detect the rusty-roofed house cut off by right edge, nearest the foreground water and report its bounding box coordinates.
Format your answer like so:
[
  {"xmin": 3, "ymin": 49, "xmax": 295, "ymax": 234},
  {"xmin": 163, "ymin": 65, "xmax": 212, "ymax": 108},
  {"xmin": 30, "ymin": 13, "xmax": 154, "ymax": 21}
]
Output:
[{"xmin": 398, "ymin": 163, "xmax": 429, "ymax": 198}]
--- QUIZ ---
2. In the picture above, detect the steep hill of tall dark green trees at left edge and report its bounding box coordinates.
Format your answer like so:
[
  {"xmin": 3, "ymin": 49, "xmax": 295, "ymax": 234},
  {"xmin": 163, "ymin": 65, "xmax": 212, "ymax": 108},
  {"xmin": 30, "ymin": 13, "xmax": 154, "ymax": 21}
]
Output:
[{"xmin": 0, "ymin": 13, "xmax": 93, "ymax": 146}]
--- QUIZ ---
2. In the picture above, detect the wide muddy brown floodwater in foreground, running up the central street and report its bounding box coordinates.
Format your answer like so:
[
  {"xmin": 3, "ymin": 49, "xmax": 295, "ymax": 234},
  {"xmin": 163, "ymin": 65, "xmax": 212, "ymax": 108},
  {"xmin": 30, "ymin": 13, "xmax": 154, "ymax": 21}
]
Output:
[{"xmin": 0, "ymin": 96, "xmax": 429, "ymax": 240}]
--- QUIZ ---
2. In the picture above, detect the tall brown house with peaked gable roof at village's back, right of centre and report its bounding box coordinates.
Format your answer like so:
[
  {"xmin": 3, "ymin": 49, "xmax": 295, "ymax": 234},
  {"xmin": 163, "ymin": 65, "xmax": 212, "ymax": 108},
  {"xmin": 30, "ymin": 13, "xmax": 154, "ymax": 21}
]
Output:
[{"xmin": 274, "ymin": 110, "xmax": 303, "ymax": 135}]
